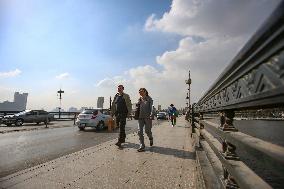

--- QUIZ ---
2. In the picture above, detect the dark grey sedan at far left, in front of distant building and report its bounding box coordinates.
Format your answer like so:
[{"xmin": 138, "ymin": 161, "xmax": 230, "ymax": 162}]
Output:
[{"xmin": 2, "ymin": 110, "xmax": 54, "ymax": 126}]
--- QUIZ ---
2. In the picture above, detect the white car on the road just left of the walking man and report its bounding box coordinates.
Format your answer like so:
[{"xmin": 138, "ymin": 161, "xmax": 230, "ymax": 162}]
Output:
[{"xmin": 76, "ymin": 109, "xmax": 112, "ymax": 130}]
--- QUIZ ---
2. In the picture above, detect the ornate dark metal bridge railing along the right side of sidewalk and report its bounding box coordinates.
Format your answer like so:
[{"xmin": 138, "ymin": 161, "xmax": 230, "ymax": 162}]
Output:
[{"xmin": 191, "ymin": 1, "xmax": 284, "ymax": 189}]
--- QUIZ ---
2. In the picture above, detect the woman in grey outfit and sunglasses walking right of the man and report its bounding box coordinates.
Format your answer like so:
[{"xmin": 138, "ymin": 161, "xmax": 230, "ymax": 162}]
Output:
[{"xmin": 137, "ymin": 88, "xmax": 153, "ymax": 152}]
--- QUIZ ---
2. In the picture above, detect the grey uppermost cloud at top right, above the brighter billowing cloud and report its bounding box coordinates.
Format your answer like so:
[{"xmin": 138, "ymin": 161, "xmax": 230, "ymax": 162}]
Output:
[{"xmin": 145, "ymin": 0, "xmax": 280, "ymax": 38}]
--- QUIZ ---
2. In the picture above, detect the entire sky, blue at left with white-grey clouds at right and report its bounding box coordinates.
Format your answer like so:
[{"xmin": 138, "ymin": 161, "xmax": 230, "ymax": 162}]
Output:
[{"xmin": 0, "ymin": 0, "xmax": 280, "ymax": 111}]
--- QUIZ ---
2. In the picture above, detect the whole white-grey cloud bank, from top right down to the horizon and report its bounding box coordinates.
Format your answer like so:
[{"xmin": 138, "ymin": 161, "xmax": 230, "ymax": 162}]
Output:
[{"xmin": 21, "ymin": 0, "xmax": 279, "ymax": 108}]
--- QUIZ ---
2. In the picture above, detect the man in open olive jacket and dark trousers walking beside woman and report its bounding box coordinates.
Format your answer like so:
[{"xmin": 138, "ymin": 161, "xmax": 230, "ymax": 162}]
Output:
[{"xmin": 111, "ymin": 85, "xmax": 132, "ymax": 148}]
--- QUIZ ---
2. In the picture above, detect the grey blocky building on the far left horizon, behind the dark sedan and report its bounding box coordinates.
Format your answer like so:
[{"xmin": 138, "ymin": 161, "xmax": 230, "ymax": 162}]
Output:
[{"xmin": 0, "ymin": 92, "xmax": 28, "ymax": 111}]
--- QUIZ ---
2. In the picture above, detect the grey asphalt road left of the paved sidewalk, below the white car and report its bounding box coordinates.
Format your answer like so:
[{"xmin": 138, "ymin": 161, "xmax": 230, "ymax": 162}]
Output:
[{"xmin": 0, "ymin": 120, "xmax": 160, "ymax": 177}]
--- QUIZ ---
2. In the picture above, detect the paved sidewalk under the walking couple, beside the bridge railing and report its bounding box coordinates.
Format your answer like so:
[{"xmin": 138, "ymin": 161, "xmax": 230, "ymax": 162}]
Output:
[{"xmin": 0, "ymin": 118, "xmax": 196, "ymax": 189}]
